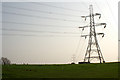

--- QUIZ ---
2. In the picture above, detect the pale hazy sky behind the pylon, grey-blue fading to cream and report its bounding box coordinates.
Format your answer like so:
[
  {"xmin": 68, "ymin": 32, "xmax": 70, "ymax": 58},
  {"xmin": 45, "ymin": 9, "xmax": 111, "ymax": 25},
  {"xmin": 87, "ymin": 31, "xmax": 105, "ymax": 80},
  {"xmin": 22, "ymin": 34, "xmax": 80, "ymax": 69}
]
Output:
[{"xmin": 2, "ymin": 0, "xmax": 118, "ymax": 64}]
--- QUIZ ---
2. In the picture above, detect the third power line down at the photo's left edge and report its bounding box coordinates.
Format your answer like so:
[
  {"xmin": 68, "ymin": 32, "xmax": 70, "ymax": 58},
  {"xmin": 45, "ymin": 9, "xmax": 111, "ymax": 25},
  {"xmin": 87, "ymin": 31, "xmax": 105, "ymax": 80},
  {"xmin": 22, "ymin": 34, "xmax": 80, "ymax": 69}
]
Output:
[{"xmin": 2, "ymin": 21, "xmax": 75, "ymax": 28}]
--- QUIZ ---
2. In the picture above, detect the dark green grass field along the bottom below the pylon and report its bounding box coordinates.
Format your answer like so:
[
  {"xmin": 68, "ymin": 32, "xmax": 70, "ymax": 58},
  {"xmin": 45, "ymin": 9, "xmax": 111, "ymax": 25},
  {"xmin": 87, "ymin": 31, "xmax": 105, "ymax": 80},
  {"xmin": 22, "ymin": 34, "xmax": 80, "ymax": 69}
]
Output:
[{"xmin": 2, "ymin": 63, "xmax": 120, "ymax": 78}]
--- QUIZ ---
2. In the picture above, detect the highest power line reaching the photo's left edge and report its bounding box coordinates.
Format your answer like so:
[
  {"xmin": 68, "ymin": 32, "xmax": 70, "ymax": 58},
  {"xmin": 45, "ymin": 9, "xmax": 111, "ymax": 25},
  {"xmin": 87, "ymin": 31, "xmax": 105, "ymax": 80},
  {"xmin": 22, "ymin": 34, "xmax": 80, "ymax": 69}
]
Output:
[{"xmin": 3, "ymin": 6, "xmax": 81, "ymax": 17}]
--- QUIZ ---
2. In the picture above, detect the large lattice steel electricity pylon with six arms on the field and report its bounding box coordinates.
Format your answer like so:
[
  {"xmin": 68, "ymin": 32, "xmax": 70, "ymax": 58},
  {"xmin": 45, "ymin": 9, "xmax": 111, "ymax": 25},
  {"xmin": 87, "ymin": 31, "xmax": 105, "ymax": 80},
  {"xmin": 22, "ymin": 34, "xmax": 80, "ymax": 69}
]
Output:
[{"xmin": 79, "ymin": 5, "xmax": 106, "ymax": 63}]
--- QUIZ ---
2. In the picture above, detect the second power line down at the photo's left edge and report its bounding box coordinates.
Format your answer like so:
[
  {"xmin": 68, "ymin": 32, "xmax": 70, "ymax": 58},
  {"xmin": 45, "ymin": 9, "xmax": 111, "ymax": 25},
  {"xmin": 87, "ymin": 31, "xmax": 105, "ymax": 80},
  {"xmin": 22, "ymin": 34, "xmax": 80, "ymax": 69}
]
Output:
[{"xmin": 3, "ymin": 11, "xmax": 80, "ymax": 22}]
